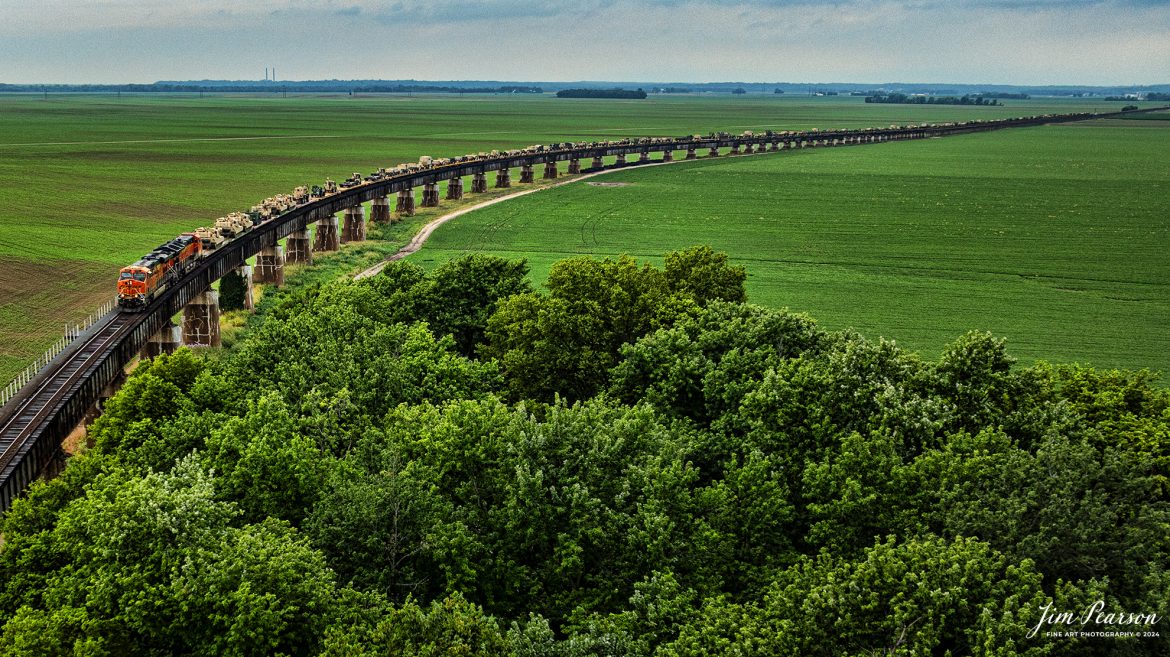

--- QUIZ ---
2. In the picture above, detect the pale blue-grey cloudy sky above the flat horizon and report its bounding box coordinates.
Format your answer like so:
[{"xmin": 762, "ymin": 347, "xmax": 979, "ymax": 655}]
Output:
[{"xmin": 0, "ymin": 0, "xmax": 1170, "ymax": 85}]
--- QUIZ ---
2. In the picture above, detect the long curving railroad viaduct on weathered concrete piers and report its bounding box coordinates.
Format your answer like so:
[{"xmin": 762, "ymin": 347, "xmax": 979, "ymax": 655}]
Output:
[{"xmin": 0, "ymin": 108, "xmax": 1165, "ymax": 513}]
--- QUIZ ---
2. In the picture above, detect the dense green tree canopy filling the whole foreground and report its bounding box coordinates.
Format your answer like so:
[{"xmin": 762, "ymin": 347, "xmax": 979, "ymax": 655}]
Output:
[{"xmin": 0, "ymin": 247, "xmax": 1170, "ymax": 657}]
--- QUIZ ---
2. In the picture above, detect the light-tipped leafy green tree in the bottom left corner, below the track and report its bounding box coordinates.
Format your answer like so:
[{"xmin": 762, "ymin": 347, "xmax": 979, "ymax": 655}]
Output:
[{"xmin": 0, "ymin": 459, "xmax": 333, "ymax": 655}]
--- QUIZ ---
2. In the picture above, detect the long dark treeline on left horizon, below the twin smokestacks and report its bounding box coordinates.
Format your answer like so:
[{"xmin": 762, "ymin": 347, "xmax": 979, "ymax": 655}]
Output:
[{"xmin": 0, "ymin": 82, "xmax": 544, "ymax": 94}]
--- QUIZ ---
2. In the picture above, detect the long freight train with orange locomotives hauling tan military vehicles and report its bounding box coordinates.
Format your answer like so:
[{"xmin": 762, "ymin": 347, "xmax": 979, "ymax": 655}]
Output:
[{"xmin": 117, "ymin": 112, "xmax": 1137, "ymax": 312}]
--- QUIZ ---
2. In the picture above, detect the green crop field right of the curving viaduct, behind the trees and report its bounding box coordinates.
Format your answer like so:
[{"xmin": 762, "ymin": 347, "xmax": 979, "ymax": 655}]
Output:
[{"xmin": 415, "ymin": 120, "xmax": 1170, "ymax": 372}]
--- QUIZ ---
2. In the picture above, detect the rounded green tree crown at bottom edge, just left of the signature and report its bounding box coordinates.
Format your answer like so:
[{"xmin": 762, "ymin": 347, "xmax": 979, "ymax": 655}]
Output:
[{"xmin": 661, "ymin": 538, "xmax": 1054, "ymax": 657}]
